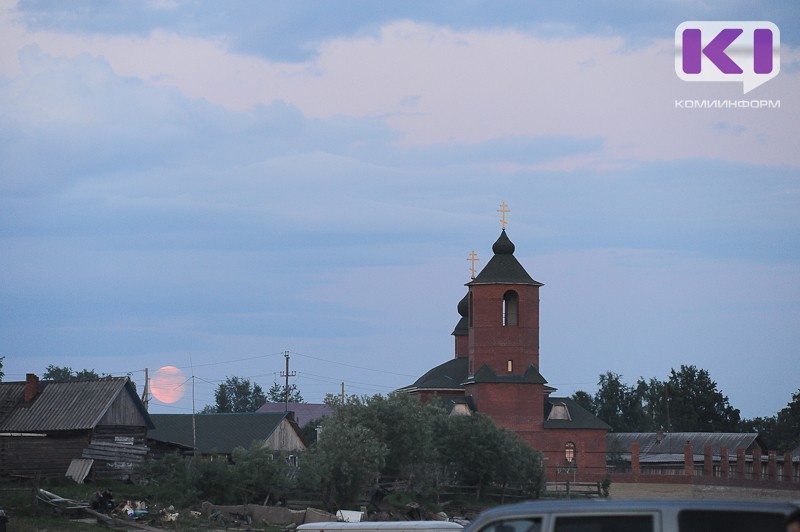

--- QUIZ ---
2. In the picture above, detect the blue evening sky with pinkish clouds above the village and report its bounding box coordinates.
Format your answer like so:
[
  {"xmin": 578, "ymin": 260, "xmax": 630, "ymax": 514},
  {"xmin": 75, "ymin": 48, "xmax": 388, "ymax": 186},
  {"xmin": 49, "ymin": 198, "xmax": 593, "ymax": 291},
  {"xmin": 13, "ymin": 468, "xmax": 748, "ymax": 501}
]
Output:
[{"xmin": 0, "ymin": 0, "xmax": 800, "ymax": 418}]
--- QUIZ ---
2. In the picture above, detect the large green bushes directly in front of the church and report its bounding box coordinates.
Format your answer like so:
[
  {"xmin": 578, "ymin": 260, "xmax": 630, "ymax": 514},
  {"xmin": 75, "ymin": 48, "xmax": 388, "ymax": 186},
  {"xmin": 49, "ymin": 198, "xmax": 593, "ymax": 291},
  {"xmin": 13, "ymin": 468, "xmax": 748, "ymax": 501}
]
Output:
[{"xmin": 300, "ymin": 393, "xmax": 544, "ymax": 505}]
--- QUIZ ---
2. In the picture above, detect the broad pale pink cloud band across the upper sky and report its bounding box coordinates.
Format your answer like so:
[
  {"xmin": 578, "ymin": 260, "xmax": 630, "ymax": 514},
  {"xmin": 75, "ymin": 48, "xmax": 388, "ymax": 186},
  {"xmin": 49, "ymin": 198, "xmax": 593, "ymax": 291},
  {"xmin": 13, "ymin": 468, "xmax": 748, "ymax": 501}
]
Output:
[{"xmin": 5, "ymin": 10, "xmax": 800, "ymax": 168}]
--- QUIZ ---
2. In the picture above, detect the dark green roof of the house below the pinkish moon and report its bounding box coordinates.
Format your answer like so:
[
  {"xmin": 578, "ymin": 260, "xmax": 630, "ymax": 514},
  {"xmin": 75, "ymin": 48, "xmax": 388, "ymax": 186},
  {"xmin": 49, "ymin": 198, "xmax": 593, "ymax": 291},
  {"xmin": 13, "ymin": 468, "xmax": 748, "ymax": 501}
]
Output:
[{"xmin": 147, "ymin": 412, "xmax": 300, "ymax": 454}]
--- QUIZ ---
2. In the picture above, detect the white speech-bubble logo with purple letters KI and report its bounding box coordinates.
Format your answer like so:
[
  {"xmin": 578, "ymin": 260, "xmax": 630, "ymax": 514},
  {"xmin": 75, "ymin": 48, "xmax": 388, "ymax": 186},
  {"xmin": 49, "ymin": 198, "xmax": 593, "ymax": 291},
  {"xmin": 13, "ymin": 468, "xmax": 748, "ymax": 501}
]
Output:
[{"xmin": 675, "ymin": 21, "xmax": 781, "ymax": 94}]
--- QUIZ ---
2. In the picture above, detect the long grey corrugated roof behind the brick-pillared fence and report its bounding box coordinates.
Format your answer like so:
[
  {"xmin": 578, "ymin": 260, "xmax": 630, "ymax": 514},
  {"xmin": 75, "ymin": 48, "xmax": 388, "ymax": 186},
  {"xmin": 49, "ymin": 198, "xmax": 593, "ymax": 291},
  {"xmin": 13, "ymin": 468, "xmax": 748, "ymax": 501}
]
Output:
[{"xmin": 606, "ymin": 432, "xmax": 765, "ymax": 462}]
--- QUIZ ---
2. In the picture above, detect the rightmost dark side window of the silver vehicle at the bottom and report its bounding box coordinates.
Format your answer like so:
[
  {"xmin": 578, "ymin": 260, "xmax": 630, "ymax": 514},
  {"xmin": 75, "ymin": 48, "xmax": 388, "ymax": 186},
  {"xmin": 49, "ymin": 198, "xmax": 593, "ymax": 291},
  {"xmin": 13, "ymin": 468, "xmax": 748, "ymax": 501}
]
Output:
[{"xmin": 678, "ymin": 510, "xmax": 786, "ymax": 532}]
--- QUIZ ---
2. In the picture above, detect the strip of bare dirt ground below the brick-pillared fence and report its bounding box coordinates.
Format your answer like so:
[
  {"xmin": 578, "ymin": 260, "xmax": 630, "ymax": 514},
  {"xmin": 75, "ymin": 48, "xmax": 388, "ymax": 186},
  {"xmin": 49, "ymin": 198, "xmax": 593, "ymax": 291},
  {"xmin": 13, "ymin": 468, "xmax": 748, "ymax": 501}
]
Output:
[{"xmin": 609, "ymin": 483, "xmax": 800, "ymax": 501}]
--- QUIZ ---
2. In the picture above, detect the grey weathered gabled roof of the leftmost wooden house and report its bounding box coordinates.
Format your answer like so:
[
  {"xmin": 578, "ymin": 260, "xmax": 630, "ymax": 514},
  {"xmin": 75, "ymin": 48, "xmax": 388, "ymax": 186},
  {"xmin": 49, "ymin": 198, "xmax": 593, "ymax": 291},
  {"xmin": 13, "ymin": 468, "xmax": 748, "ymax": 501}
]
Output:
[{"xmin": 0, "ymin": 377, "xmax": 153, "ymax": 432}]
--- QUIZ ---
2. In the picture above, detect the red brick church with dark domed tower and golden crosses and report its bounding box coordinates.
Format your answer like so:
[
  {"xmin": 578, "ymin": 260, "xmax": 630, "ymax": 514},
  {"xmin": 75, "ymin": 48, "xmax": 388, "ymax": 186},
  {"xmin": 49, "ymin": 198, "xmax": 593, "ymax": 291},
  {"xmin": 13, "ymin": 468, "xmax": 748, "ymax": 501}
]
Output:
[{"xmin": 399, "ymin": 204, "xmax": 610, "ymax": 481}]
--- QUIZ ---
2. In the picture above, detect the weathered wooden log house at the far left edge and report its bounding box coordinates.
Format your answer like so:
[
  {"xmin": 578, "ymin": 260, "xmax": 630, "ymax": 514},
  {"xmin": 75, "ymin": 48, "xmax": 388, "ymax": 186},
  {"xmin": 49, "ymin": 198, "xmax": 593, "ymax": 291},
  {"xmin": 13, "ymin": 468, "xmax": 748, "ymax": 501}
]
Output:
[{"xmin": 0, "ymin": 374, "xmax": 153, "ymax": 482}]
